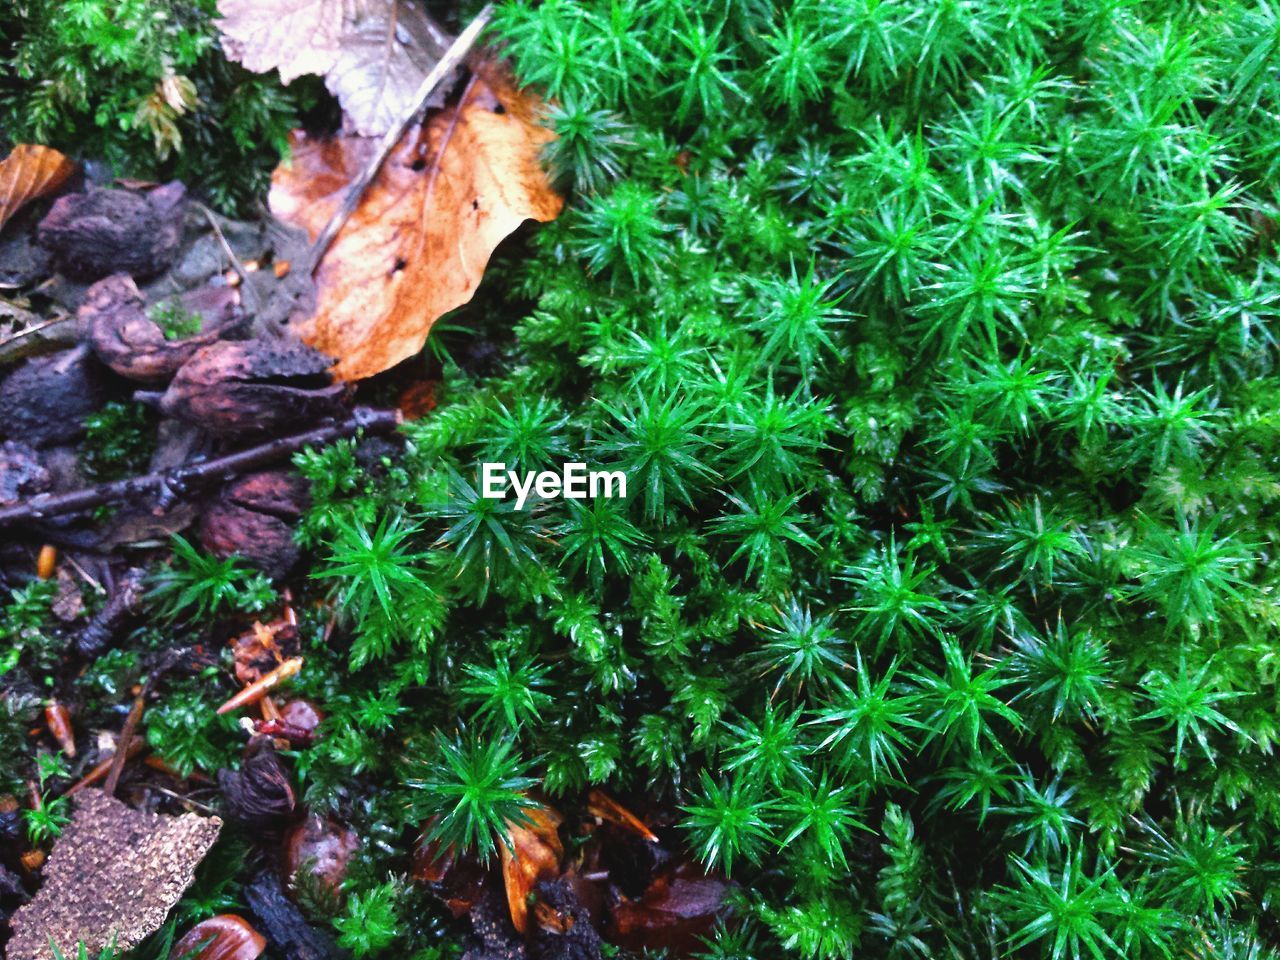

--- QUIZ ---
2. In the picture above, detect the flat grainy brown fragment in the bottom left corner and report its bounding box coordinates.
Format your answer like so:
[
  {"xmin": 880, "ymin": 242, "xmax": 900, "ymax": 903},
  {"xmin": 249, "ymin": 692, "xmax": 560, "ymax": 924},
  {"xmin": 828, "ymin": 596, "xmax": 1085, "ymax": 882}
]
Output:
[{"xmin": 5, "ymin": 790, "xmax": 223, "ymax": 960}]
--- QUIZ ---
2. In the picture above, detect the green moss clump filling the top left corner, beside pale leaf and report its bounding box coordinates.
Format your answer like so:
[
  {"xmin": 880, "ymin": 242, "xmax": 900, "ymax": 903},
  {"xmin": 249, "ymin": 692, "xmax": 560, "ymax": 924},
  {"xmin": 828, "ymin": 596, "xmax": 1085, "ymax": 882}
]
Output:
[{"xmin": 0, "ymin": 0, "xmax": 314, "ymax": 210}]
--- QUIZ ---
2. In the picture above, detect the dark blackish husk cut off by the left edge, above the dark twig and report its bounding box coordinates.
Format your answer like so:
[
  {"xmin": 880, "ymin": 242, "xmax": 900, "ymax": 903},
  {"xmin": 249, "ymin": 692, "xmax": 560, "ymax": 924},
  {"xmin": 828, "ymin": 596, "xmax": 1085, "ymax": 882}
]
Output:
[{"xmin": 0, "ymin": 347, "xmax": 105, "ymax": 449}]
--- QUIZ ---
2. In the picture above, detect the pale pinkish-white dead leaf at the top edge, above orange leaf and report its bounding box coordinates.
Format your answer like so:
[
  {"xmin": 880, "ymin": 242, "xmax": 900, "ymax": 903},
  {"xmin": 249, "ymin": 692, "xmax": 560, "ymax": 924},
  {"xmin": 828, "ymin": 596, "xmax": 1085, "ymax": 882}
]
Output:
[{"xmin": 218, "ymin": 0, "xmax": 452, "ymax": 137}]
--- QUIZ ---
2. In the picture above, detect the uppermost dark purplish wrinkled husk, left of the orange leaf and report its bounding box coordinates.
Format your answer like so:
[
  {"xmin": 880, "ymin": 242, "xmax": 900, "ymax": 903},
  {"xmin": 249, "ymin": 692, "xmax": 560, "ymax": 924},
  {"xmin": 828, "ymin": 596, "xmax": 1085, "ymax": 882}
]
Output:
[{"xmin": 36, "ymin": 182, "xmax": 187, "ymax": 280}]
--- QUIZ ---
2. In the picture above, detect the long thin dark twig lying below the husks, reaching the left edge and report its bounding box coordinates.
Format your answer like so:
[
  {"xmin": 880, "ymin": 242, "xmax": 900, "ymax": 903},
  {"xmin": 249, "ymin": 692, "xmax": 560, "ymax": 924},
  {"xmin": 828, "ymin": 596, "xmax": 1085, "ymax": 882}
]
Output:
[{"xmin": 0, "ymin": 407, "xmax": 401, "ymax": 529}]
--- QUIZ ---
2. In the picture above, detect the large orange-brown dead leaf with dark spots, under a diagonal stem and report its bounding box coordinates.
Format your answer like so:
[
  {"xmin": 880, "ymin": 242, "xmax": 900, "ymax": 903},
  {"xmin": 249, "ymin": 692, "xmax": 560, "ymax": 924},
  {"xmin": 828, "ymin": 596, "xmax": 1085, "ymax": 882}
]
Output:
[{"xmin": 270, "ymin": 58, "xmax": 564, "ymax": 380}]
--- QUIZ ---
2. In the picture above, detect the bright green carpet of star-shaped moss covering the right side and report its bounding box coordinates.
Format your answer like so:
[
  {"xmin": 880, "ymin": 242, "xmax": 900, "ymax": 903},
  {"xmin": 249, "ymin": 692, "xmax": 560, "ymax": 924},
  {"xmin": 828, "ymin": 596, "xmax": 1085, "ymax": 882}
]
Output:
[{"xmin": 0, "ymin": 0, "xmax": 1280, "ymax": 960}]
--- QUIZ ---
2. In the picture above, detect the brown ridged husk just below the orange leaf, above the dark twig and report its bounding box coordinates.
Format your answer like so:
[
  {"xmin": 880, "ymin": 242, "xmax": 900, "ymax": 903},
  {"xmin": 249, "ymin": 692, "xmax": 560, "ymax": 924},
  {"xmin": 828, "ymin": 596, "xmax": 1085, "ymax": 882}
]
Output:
[{"xmin": 160, "ymin": 338, "xmax": 348, "ymax": 436}]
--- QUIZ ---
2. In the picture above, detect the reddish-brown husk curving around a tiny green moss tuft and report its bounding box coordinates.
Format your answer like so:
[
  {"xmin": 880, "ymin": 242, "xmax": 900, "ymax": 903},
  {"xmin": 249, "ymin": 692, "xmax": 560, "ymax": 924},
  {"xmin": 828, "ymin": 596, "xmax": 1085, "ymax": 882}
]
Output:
[{"xmin": 79, "ymin": 274, "xmax": 239, "ymax": 384}]
